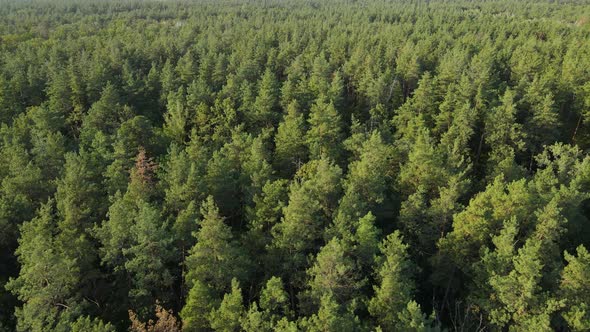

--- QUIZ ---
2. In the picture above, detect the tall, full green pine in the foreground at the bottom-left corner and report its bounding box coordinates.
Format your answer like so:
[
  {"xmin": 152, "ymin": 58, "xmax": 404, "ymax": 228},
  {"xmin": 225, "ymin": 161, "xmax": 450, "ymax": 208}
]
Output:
[{"xmin": 6, "ymin": 201, "xmax": 80, "ymax": 331}]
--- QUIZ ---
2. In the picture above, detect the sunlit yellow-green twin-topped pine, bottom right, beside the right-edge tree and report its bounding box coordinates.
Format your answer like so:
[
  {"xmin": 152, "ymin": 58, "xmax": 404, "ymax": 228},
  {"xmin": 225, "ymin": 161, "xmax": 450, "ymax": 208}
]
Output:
[{"xmin": 474, "ymin": 200, "xmax": 565, "ymax": 329}]
